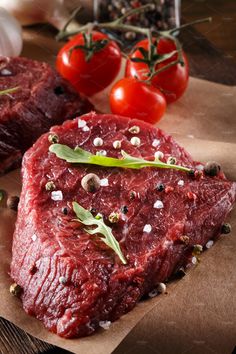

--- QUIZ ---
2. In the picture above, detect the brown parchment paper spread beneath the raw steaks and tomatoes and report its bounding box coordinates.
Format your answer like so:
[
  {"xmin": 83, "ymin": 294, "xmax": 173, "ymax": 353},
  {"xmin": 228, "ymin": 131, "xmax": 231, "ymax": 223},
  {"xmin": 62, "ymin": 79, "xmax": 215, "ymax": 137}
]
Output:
[{"xmin": 0, "ymin": 32, "xmax": 236, "ymax": 354}]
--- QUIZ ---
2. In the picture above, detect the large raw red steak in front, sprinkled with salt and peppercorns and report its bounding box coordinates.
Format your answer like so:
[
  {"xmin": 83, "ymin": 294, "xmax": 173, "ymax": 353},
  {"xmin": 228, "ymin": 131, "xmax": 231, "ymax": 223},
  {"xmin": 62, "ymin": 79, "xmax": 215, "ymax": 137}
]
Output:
[{"xmin": 11, "ymin": 113, "xmax": 236, "ymax": 338}]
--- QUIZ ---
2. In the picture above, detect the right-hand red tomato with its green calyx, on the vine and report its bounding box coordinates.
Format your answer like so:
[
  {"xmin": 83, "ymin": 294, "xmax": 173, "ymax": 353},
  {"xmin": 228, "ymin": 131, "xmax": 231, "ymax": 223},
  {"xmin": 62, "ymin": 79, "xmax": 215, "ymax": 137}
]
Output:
[{"xmin": 126, "ymin": 37, "xmax": 189, "ymax": 103}]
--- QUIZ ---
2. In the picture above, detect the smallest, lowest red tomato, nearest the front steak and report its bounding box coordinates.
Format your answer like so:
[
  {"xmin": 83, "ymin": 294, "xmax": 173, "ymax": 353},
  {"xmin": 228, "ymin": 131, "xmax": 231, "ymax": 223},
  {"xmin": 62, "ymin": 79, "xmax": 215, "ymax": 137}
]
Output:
[{"xmin": 110, "ymin": 78, "xmax": 166, "ymax": 124}]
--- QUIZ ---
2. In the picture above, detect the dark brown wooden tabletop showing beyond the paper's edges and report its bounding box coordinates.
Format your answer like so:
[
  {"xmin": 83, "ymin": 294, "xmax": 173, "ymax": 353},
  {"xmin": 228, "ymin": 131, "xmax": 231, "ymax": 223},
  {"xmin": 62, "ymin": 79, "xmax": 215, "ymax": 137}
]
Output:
[{"xmin": 0, "ymin": 22, "xmax": 236, "ymax": 354}]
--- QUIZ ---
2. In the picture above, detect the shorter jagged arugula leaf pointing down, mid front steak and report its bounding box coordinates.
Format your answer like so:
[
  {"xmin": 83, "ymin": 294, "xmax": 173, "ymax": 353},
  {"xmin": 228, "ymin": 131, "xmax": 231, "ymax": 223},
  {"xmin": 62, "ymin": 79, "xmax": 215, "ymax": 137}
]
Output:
[{"xmin": 72, "ymin": 202, "xmax": 127, "ymax": 264}]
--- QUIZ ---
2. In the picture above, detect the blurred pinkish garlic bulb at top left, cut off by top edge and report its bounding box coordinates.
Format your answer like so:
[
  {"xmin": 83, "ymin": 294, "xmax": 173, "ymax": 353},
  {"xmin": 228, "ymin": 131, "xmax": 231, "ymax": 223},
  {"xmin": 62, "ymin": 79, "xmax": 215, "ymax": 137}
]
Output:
[{"xmin": 0, "ymin": 0, "xmax": 80, "ymax": 30}]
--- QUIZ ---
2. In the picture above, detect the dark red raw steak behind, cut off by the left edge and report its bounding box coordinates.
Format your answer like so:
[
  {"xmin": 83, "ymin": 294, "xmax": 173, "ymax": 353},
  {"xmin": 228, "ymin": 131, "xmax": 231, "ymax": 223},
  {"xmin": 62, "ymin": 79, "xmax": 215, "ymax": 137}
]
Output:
[{"xmin": 0, "ymin": 57, "xmax": 91, "ymax": 174}]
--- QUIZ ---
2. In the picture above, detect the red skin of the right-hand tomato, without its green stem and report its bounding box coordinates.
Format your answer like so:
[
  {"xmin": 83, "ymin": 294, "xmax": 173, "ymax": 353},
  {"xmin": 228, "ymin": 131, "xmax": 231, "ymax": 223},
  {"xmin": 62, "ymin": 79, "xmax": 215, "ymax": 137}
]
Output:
[{"xmin": 126, "ymin": 38, "xmax": 189, "ymax": 103}]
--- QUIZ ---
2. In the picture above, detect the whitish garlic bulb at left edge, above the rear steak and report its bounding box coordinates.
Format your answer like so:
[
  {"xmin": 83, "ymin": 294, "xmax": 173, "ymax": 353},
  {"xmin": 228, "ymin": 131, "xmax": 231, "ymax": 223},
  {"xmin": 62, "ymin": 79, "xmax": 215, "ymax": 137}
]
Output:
[{"xmin": 0, "ymin": 7, "xmax": 23, "ymax": 57}]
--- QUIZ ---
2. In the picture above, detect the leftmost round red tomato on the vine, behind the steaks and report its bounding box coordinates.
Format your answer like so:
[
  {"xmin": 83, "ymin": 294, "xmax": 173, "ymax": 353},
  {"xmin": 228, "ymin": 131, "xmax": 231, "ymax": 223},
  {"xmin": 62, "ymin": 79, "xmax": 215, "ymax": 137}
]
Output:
[{"xmin": 56, "ymin": 31, "xmax": 121, "ymax": 96}]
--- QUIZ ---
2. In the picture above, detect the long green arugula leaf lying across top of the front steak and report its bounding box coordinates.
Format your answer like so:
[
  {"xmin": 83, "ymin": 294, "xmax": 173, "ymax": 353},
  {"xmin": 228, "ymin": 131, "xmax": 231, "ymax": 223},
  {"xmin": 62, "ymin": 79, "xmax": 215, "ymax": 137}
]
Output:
[{"xmin": 49, "ymin": 144, "xmax": 191, "ymax": 172}]
